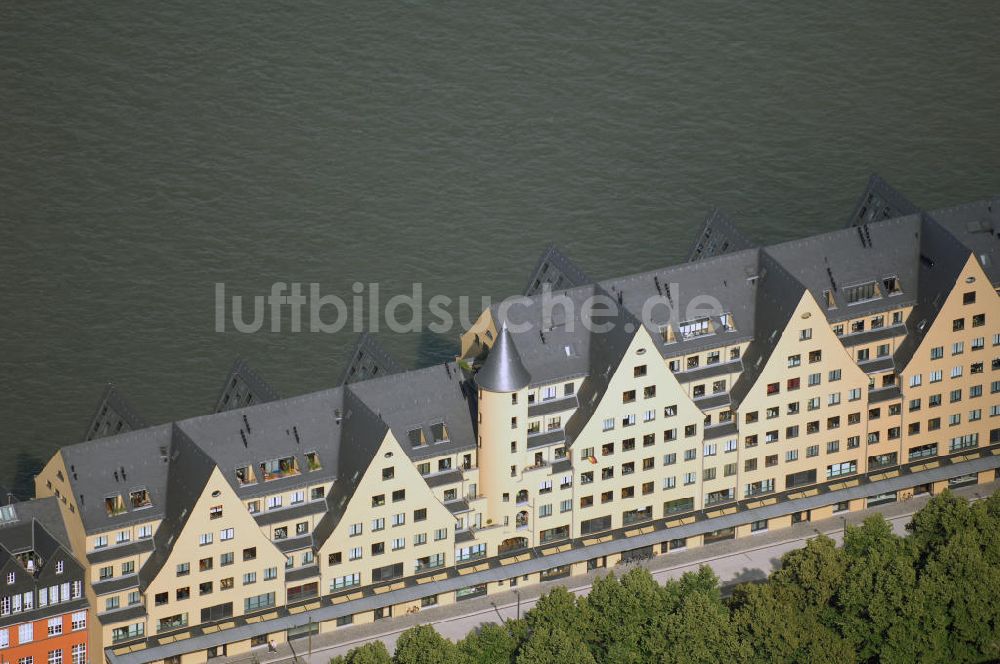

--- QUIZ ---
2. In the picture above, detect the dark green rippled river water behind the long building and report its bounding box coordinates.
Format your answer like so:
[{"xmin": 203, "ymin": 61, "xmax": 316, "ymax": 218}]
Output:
[{"xmin": 0, "ymin": 0, "xmax": 1000, "ymax": 492}]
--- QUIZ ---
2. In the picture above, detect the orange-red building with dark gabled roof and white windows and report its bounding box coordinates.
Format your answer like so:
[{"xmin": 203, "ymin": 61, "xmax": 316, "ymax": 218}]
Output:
[{"xmin": 0, "ymin": 498, "xmax": 89, "ymax": 664}]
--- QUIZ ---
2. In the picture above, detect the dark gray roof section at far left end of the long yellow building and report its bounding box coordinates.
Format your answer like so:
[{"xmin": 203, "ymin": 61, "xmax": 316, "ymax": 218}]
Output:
[{"xmin": 61, "ymin": 424, "xmax": 173, "ymax": 533}]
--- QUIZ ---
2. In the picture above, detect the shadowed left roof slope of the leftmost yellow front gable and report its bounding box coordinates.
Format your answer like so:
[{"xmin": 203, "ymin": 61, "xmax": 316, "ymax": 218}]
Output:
[{"xmin": 139, "ymin": 424, "xmax": 215, "ymax": 590}]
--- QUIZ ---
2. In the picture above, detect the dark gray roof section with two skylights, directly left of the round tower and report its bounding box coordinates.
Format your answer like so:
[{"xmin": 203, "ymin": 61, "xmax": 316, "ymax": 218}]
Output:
[{"xmin": 348, "ymin": 362, "xmax": 476, "ymax": 459}]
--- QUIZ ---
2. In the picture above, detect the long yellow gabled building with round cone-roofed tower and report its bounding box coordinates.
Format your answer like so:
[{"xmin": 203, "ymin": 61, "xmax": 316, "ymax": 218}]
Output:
[{"xmin": 36, "ymin": 178, "xmax": 1000, "ymax": 664}]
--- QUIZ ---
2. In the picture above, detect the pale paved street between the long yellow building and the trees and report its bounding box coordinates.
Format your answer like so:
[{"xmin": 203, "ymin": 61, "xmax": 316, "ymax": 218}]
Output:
[{"xmin": 225, "ymin": 481, "xmax": 1000, "ymax": 664}]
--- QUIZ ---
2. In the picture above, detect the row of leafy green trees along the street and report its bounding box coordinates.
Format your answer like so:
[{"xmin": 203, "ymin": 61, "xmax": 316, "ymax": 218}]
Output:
[{"xmin": 331, "ymin": 492, "xmax": 1000, "ymax": 664}]
